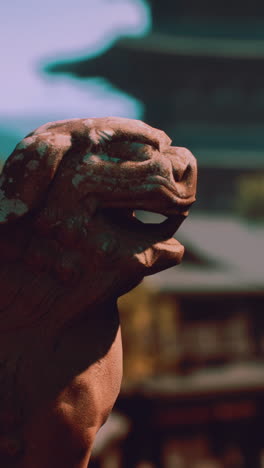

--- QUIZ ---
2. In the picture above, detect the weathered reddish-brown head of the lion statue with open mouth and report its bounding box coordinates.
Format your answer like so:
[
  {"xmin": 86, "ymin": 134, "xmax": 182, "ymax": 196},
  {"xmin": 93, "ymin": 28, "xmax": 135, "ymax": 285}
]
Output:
[{"xmin": 0, "ymin": 117, "xmax": 196, "ymax": 330}]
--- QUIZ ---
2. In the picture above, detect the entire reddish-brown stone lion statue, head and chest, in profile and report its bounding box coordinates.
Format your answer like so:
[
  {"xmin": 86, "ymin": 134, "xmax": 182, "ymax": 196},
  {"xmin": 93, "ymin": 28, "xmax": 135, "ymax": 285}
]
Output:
[{"xmin": 0, "ymin": 117, "xmax": 196, "ymax": 468}]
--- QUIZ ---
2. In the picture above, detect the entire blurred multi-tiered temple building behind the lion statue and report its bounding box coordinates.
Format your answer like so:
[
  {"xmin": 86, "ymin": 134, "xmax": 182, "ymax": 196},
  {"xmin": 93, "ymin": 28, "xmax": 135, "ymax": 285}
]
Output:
[{"xmin": 83, "ymin": 0, "xmax": 264, "ymax": 468}]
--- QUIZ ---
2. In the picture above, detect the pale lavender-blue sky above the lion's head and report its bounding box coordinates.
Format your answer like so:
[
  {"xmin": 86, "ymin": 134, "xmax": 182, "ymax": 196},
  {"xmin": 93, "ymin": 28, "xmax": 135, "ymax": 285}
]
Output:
[{"xmin": 0, "ymin": 0, "xmax": 151, "ymax": 157}]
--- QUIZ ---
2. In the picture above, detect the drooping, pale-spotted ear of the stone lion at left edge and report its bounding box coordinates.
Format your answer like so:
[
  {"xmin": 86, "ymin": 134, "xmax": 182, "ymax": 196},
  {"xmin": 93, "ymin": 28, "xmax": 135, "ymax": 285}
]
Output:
[{"xmin": 0, "ymin": 132, "xmax": 71, "ymax": 224}]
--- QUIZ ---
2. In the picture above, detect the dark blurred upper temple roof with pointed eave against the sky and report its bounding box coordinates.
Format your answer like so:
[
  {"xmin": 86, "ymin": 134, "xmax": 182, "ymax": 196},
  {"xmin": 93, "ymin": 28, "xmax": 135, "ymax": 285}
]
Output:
[{"xmin": 45, "ymin": 15, "xmax": 264, "ymax": 169}]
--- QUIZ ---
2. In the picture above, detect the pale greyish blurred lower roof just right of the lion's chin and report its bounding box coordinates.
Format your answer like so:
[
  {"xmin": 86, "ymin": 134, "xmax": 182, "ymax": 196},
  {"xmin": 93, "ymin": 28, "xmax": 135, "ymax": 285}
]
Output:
[{"xmin": 145, "ymin": 214, "xmax": 264, "ymax": 294}]
